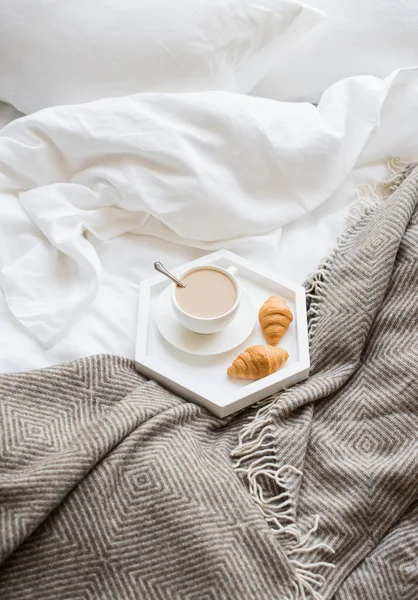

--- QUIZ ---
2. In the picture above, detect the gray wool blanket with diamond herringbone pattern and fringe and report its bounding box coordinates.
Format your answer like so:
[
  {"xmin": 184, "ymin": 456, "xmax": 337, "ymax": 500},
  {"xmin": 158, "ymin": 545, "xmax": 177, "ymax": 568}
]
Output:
[{"xmin": 0, "ymin": 165, "xmax": 418, "ymax": 600}]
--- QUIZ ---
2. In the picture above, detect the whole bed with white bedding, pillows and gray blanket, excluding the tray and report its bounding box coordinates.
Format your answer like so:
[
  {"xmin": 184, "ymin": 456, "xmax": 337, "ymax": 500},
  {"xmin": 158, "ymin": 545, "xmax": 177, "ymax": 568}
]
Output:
[{"xmin": 0, "ymin": 0, "xmax": 418, "ymax": 600}]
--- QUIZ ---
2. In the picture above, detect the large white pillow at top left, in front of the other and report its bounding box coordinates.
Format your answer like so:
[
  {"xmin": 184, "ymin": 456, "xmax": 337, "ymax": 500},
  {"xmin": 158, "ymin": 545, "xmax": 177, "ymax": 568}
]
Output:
[{"xmin": 0, "ymin": 0, "xmax": 325, "ymax": 113}]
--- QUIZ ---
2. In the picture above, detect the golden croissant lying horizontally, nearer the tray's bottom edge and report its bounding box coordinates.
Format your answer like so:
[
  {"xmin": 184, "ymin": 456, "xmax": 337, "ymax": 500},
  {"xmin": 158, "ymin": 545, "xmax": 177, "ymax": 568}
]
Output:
[{"xmin": 227, "ymin": 345, "xmax": 289, "ymax": 379}]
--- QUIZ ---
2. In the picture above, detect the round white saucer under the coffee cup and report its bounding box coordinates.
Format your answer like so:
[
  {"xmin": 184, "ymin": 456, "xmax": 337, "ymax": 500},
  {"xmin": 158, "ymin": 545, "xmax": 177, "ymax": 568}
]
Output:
[{"xmin": 155, "ymin": 286, "xmax": 256, "ymax": 356}]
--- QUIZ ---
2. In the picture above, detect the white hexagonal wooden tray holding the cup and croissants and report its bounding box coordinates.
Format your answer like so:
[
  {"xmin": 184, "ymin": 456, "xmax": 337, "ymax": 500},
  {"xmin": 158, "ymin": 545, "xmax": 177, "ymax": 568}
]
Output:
[{"xmin": 135, "ymin": 250, "xmax": 309, "ymax": 417}]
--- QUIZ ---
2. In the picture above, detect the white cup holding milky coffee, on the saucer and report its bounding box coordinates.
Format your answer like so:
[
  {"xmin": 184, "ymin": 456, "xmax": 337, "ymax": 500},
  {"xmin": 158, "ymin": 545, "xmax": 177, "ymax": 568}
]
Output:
[{"xmin": 171, "ymin": 265, "xmax": 241, "ymax": 334}]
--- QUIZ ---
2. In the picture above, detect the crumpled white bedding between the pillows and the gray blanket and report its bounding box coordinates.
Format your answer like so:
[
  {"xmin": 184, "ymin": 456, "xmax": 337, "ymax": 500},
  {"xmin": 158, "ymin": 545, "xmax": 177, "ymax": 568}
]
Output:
[{"xmin": 0, "ymin": 69, "xmax": 418, "ymax": 371}]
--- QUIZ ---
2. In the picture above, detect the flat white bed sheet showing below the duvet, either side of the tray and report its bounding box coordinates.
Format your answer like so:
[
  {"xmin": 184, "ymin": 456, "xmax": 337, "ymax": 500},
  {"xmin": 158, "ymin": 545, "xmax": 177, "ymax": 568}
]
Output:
[{"xmin": 0, "ymin": 160, "xmax": 396, "ymax": 373}]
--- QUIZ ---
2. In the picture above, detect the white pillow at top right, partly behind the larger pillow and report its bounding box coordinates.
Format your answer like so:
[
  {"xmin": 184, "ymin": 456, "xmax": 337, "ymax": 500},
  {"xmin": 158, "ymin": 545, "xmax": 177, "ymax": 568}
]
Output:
[{"xmin": 252, "ymin": 0, "xmax": 418, "ymax": 102}]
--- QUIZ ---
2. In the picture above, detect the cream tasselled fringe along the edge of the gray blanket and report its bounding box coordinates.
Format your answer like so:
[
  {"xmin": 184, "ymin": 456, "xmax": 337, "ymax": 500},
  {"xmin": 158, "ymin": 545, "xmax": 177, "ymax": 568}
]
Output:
[{"xmin": 232, "ymin": 157, "xmax": 410, "ymax": 600}]
